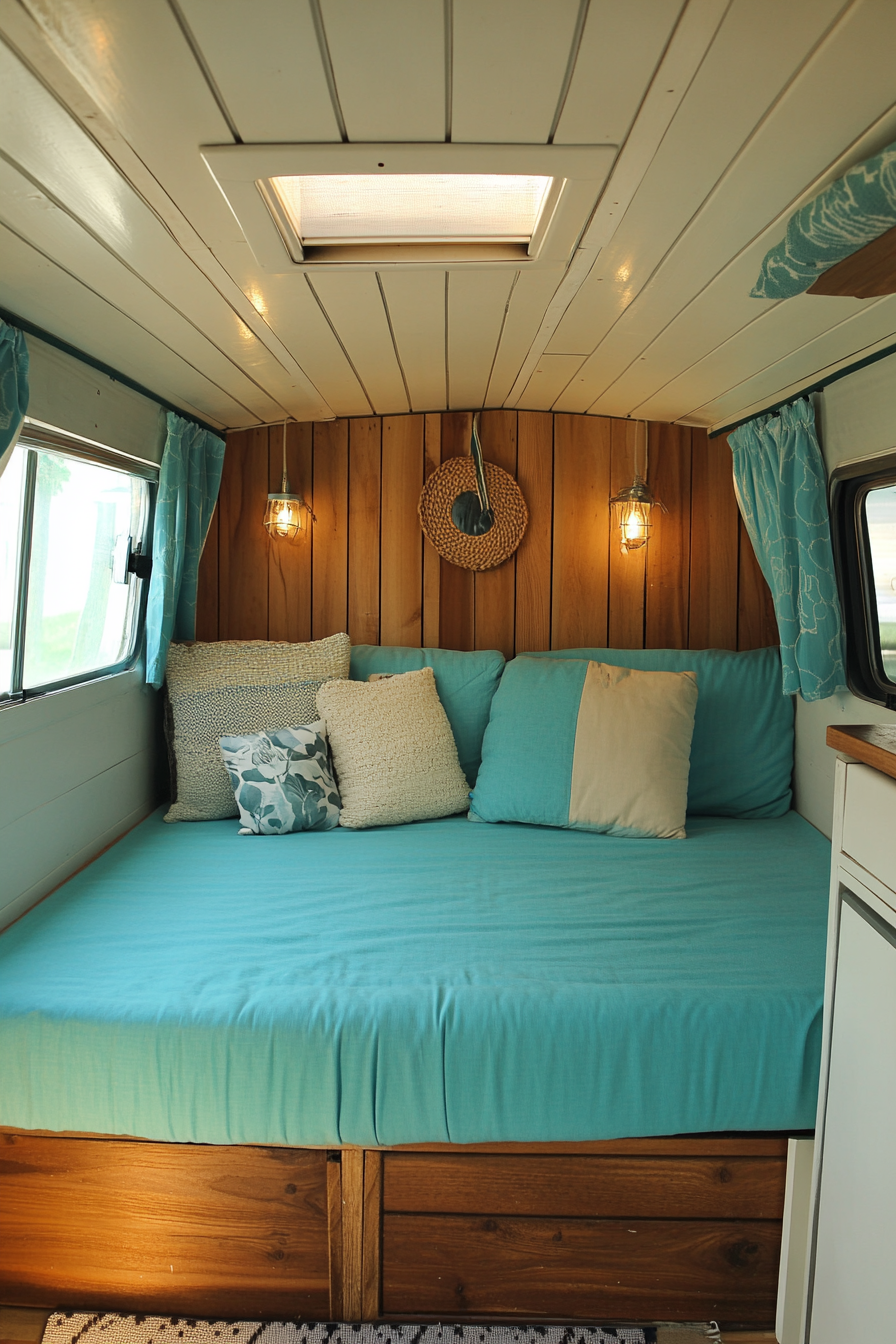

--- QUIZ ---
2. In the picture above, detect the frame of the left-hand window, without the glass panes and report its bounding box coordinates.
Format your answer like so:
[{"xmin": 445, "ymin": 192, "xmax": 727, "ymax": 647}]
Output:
[{"xmin": 0, "ymin": 417, "xmax": 159, "ymax": 711}]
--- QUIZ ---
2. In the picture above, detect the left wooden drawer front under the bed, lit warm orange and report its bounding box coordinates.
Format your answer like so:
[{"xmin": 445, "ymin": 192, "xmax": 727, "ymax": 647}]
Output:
[{"xmin": 0, "ymin": 1134, "xmax": 329, "ymax": 1320}]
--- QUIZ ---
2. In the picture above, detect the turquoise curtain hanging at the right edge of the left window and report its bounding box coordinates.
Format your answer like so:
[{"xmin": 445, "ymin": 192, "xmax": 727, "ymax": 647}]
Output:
[{"xmin": 146, "ymin": 411, "xmax": 225, "ymax": 688}]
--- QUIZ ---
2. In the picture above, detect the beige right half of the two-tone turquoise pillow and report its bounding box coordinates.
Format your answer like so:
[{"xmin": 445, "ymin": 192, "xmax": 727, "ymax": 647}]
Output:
[{"xmin": 570, "ymin": 663, "xmax": 697, "ymax": 840}]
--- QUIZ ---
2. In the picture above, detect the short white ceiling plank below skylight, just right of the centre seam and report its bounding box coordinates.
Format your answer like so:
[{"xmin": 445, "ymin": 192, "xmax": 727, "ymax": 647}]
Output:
[{"xmin": 447, "ymin": 270, "xmax": 513, "ymax": 410}]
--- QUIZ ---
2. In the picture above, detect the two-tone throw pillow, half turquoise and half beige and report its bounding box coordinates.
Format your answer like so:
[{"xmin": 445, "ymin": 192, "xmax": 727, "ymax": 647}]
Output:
[{"xmin": 470, "ymin": 657, "xmax": 697, "ymax": 839}]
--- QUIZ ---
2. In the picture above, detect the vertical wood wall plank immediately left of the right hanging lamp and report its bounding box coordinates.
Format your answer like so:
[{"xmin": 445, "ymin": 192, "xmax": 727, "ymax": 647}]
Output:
[{"xmin": 551, "ymin": 415, "xmax": 613, "ymax": 649}]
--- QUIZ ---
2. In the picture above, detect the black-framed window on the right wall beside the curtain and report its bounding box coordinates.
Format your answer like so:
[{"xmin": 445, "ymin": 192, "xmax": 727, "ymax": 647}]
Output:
[{"xmin": 832, "ymin": 454, "xmax": 896, "ymax": 708}]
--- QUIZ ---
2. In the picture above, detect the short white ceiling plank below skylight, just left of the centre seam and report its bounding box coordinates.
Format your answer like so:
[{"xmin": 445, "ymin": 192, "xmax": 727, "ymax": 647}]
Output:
[{"xmin": 380, "ymin": 270, "xmax": 447, "ymax": 411}]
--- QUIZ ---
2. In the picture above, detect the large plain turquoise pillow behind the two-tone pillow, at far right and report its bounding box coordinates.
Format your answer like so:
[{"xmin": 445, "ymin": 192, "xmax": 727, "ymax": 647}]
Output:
[{"xmin": 525, "ymin": 648, "xmax": 794, "ymax": 817}]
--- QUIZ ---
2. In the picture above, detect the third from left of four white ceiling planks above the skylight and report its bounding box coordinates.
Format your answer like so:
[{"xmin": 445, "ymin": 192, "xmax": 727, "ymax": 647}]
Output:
[{"xmin": 451, "ymin": 0, "xmax": 579, "ymax": 145}]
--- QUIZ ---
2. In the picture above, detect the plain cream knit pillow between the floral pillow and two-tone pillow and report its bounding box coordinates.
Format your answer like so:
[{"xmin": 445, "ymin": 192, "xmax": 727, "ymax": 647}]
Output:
[{"xmin": 317, "ymin": 668, "xmax": 470, "ymax": 829}]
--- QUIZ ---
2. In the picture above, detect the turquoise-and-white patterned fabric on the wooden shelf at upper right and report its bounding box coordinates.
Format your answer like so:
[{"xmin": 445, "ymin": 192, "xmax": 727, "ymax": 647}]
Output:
[{"xmin": 751, "ymin": 142, "xmax": 896, "ymax": 298}]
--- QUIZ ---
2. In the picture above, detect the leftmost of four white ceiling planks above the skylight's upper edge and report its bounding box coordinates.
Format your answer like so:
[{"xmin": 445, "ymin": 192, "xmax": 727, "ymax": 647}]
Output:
[{"xmin": 179, "ymin": 0, "xmax": 341, "ymax": 144}]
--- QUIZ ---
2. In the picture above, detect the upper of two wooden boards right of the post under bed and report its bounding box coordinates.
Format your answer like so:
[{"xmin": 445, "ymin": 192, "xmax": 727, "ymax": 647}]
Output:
[{"xmin": 383, "ymin": 1153, "xmax": 786, "ymax": 1219}]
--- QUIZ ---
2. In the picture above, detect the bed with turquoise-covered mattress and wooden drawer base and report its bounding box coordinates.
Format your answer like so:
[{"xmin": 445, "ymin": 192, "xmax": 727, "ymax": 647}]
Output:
[{"xmin": 0, "ymin": 813, "xmax": 829, "ymax": 1328}]
